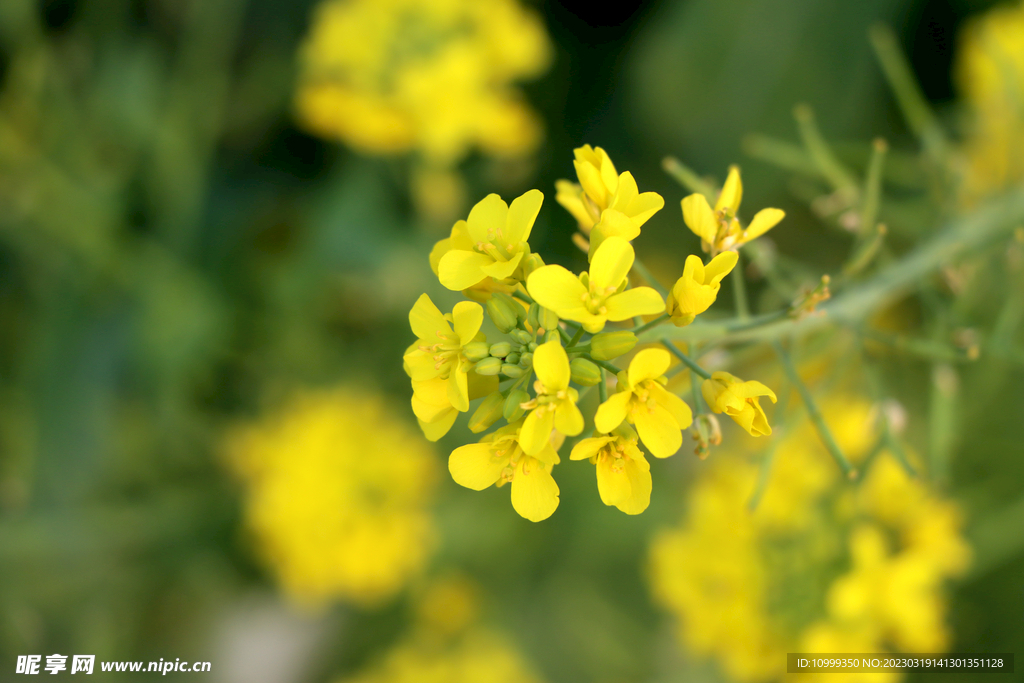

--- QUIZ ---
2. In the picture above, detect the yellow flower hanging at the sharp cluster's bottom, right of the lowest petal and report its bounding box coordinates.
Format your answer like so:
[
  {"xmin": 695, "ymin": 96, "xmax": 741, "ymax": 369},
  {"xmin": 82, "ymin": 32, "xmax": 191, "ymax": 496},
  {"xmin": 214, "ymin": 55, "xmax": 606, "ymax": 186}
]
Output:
[{"xmin": 569, "ymin": 425, "xmax": 651, "ymax": 515}]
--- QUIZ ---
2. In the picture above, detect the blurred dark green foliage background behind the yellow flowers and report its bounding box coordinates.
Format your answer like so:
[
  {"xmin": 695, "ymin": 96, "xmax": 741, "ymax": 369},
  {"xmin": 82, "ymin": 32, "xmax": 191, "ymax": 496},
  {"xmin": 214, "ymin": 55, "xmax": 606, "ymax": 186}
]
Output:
[{"xmin": 0, "ymin": 0, "xmax": 1024, "ymax": 683}]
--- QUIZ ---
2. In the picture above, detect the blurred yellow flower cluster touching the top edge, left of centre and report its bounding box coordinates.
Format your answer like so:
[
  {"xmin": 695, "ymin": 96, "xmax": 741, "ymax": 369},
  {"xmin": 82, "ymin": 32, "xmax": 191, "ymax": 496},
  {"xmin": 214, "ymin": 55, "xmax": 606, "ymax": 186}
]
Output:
[{"xmin": 296, "ymin": 0, "xmax": 552, "ymax": 168}]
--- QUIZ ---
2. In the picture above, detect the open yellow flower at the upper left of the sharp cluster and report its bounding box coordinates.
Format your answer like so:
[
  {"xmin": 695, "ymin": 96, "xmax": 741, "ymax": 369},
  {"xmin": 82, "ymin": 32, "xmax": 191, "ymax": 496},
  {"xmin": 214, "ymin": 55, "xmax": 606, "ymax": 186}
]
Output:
[{"xmin": 437, "ymin": 189, "xmax": 544, "ymax": 291}]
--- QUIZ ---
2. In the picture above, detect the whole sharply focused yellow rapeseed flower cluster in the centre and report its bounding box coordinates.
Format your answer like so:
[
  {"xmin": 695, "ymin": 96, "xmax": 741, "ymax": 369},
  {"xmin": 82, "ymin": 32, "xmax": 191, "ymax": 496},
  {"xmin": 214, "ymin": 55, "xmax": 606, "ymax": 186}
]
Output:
[{"xmin": 404, "ymin": 145, "xmax": 781, "ymax": 521}]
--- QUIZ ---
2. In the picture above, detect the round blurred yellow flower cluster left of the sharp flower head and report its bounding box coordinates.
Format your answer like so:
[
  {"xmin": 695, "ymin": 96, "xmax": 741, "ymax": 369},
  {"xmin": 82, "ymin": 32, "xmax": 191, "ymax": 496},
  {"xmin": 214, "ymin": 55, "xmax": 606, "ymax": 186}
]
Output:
[{"xmin": 226, "ymin": 388, "xmax": 437, "ymax": 604}]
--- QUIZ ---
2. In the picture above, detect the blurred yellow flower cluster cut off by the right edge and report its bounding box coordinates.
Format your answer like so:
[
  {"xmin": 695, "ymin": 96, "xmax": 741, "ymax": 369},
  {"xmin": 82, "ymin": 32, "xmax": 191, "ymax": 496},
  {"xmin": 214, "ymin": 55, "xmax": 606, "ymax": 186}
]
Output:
[{"xmin": 953, "ymin": 2, "xmax": 1024, "ymax": 205}]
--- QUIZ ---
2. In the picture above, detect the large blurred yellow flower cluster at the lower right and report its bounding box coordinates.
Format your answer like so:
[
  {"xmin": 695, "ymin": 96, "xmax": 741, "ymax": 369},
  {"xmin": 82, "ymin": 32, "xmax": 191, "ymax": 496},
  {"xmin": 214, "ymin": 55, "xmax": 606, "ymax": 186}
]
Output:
[{"xmin": 649, "ymin": 396, "xmax": 970, "ymax": 683}]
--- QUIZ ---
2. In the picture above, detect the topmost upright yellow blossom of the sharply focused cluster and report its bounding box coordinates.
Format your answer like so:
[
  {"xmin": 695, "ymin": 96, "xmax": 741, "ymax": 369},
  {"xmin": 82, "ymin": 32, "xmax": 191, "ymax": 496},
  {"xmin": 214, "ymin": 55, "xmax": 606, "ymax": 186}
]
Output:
[{"xmin": 555, "ymin": 144, "xmax": 665, "ymax": 256}]
